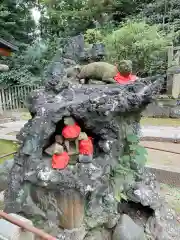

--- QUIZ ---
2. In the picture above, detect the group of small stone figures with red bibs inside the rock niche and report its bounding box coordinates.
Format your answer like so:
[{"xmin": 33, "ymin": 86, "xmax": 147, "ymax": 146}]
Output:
[{"xmin": 44, "ymin": 117, "xmax": 93, "ymax": 166}]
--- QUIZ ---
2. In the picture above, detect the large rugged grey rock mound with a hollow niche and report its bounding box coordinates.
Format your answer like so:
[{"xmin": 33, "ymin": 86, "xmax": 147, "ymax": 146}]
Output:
[{"xmin": 2, "ymin": 34, "xmax": 180, "ymax": 240}]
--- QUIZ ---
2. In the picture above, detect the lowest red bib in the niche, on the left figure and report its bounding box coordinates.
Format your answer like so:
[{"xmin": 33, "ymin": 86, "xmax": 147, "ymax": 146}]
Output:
[{"xmin": 52, "ymin": 152, "xmax": 70, "ymax": 169}]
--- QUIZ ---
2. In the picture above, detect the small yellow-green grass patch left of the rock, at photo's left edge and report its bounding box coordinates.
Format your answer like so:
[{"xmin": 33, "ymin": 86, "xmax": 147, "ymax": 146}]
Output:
[{"xmin": 0, "ymin": 139, "xmax": 18, "ymax": 163}]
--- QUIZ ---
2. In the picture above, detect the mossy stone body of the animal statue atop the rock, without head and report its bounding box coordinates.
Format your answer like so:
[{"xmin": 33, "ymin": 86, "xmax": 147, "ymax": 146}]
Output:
[{"xmin": 77, "ymin": 62, "xmax": 118, "ymax": 84}]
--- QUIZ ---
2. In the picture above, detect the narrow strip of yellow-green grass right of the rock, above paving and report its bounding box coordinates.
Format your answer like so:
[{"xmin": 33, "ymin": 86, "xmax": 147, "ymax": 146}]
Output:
[{"xmin": 141, "ymin": 117, "xmax": 180, "ymax": 127}]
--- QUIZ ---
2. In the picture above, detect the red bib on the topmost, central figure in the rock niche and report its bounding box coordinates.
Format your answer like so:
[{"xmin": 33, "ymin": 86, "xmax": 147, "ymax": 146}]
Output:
[{"xmin": 62, "ymin": 123, "xmax": 81, "ymax": 139}]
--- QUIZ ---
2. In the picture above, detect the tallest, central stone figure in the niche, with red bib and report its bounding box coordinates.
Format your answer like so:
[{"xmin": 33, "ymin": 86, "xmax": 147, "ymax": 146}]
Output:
[{"xmin": 62, "ymin": 117, "xmax": 81, "ymax": 155}]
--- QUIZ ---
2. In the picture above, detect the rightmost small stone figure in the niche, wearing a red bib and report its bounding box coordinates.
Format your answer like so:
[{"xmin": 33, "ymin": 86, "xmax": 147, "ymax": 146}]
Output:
[{"xmin": 79, "ymin": 132, "xmax": 93, "ymax": 163}]
